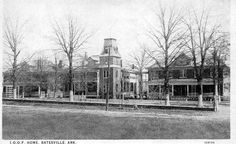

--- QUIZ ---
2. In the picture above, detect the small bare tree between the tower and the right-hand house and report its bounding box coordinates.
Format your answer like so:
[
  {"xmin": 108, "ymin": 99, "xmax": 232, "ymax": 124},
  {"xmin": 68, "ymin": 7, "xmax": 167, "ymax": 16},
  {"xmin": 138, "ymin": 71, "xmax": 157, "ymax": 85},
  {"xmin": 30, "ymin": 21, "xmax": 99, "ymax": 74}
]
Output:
[{"xmin": 129, "ymin": 45, "xmax": 150, "ymax": 99}]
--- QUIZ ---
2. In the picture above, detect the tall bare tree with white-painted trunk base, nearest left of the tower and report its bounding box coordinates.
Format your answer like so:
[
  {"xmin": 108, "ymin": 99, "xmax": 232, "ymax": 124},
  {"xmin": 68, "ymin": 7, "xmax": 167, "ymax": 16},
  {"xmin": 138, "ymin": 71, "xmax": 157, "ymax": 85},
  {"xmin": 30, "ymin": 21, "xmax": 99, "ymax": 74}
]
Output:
[{"xmin": 53, "ymin": 18, "xmax": 92, "ymax": 101}]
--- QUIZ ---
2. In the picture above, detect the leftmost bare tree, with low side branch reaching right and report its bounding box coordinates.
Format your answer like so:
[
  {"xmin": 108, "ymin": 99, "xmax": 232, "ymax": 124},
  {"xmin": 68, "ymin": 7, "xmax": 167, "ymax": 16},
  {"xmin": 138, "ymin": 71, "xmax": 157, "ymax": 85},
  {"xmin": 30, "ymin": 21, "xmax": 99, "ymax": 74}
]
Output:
[{"xmin": 3, "ymin": 17, "xmax": 33, "ymax": 99}]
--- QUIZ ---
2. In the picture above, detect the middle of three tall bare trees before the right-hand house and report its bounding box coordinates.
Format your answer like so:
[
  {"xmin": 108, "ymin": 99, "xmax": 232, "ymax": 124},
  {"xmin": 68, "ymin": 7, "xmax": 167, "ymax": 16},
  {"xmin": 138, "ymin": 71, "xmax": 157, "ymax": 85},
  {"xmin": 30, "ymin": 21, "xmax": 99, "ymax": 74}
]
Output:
[{"xmin": 184, "ymin": 10, "xmax": 219, "ymax": 107}]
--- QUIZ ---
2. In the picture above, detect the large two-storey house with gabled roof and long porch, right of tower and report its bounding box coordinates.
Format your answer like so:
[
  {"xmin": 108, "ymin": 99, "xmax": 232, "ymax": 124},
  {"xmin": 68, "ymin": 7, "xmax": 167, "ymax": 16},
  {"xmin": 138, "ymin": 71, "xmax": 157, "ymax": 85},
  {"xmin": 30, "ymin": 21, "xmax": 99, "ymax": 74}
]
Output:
[{"xmin": 148, "ymin": 53, "xmax": 229, "ymax": 99}]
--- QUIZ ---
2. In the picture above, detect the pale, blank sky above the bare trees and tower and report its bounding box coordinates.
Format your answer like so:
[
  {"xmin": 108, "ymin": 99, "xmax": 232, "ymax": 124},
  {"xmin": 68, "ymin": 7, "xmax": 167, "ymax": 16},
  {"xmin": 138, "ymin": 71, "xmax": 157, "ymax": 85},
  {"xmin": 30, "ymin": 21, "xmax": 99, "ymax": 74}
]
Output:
[{"xmin": 3, "ymin": 0, "xmax": 230, "ymax": 67}]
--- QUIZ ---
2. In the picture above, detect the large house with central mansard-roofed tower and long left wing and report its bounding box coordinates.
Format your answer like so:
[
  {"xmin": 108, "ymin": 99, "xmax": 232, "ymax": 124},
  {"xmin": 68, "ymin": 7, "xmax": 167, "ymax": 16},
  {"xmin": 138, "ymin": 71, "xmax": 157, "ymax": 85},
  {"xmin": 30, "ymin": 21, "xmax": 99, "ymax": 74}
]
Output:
[{"xmin": 3, "ymin": 38, "xmax": 144, "ymax": 98}]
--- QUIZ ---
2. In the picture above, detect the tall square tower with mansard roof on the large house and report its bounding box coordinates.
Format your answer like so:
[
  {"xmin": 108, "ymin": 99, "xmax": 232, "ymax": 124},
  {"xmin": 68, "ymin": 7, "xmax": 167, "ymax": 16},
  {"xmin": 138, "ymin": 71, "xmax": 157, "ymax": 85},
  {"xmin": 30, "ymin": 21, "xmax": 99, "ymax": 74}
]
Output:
[{"xmin": 99, "ymin": 38, "xmax": 122, "ymax": 98}]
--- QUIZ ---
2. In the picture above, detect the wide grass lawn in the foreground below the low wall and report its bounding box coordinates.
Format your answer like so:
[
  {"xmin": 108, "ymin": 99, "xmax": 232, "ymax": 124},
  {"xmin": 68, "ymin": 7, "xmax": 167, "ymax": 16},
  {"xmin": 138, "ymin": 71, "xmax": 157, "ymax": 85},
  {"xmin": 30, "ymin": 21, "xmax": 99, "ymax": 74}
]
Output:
[{"xmin": 3, "ymin": 106, "xmax": 230, "ymax": 139}]
